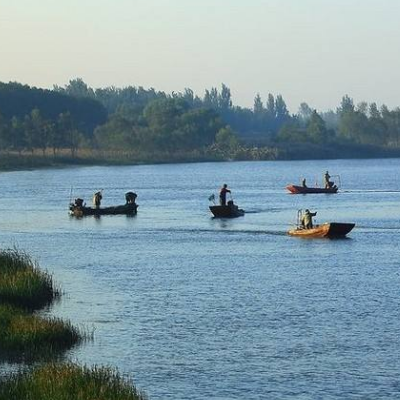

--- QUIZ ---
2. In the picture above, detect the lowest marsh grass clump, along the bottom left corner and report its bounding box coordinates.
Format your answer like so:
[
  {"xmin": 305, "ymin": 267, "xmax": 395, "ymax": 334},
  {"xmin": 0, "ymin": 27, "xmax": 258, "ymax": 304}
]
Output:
[{"xmin": 0, "ymin": 363, "xmax": 147, "ymax": 400}]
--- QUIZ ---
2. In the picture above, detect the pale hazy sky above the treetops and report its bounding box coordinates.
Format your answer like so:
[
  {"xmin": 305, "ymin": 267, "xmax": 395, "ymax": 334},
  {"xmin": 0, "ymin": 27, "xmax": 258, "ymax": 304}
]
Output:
[{"xmin": 0, "ymin": 0, "xmax": 400, "ymax": 112}]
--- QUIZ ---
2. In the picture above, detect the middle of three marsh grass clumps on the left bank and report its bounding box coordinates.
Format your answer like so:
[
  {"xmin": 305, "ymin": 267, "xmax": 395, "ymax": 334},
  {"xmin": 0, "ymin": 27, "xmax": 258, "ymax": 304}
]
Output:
[{"xmin": 0, "ymin": 304, "xmax": 82, "ymax": 361}]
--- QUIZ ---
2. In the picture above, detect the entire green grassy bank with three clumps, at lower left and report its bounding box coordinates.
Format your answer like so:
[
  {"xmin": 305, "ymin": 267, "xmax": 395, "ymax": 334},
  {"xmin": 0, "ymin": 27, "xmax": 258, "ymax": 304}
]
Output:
[{"xmin": 0, "ymin": 249, "xmax": 146, "ymax": 400}]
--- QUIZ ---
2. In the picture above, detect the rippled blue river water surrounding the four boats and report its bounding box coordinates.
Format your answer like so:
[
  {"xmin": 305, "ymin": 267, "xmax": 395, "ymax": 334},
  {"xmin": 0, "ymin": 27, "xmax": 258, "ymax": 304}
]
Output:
[{"xmin": 0, "ymin": 160, "xmax": 400, "ymax": 400}]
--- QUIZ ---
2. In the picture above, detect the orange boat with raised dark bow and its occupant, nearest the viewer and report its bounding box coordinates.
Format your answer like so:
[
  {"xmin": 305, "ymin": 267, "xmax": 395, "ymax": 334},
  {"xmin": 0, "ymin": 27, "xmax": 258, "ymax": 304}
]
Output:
[{"xmin": 288, "ymin": 210, "xmax": 355, "ymax": 238}]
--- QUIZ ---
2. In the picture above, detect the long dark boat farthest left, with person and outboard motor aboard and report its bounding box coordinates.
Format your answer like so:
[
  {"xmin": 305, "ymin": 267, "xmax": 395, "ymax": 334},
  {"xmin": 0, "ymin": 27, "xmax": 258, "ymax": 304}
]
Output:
[{"xmin": 69, "ymin": 190, "xmax": 139, "ymax": 217}]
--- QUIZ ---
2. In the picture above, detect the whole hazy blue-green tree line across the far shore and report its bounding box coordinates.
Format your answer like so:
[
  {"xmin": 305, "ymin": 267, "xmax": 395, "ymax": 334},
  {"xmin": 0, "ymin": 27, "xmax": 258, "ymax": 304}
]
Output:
[{"xmin": 0, "ymin": 79, "xmax": 400, "ymax": 157}]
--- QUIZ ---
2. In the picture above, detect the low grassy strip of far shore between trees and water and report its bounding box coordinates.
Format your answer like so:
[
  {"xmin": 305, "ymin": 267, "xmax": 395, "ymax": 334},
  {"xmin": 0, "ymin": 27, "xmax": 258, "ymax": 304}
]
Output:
[{"xmin": 0, "ymin": 144, "xmax": 400, "ymax": 172}]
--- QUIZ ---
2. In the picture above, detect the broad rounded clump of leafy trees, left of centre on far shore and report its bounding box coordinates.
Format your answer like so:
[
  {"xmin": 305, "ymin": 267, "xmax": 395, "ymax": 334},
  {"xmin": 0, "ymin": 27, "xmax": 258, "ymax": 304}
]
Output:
[{"xmin": 95, "ymin": 97, "xmax": 222, "ymax": 151}]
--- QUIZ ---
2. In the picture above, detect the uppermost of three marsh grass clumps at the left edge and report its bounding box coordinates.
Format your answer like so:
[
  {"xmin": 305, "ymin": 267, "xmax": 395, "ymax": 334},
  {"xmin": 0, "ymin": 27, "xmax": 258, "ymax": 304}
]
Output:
[{"xmin": 0, "ymin": 249, "xmax": 59, "ymax": 310}]
